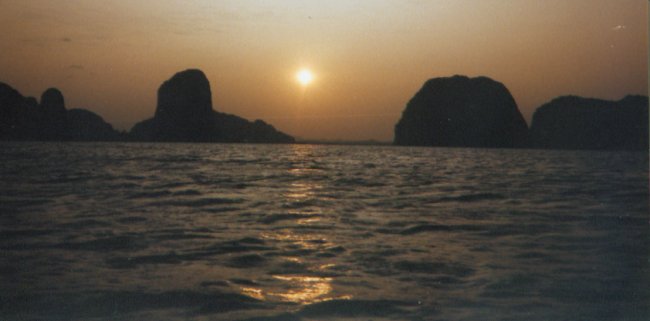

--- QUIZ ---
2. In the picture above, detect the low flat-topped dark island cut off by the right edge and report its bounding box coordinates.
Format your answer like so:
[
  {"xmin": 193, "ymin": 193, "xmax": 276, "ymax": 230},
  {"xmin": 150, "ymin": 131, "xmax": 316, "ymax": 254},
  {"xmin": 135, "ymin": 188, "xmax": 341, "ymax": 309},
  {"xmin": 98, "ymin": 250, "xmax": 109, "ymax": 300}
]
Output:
[{"xmin": 530, "ymin": 96, "xmax": 648, "ymax": 151}]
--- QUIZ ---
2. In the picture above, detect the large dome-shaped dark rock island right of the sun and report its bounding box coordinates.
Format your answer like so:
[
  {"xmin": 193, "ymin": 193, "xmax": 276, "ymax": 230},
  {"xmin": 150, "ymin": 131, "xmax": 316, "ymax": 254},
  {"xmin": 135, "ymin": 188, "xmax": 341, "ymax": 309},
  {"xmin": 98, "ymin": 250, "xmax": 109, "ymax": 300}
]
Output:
[{"xmin": 394, "ymin": 76, "xmax": 528, "ymax": 148}]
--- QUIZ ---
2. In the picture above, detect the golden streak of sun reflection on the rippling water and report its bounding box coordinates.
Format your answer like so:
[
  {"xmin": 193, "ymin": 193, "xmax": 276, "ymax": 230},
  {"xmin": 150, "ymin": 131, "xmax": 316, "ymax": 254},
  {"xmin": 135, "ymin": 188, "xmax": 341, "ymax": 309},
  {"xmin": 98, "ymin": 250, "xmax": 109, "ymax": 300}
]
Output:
[{"xmin": 235, "ymin": 146, "xmax": 352, "ymax": 305}]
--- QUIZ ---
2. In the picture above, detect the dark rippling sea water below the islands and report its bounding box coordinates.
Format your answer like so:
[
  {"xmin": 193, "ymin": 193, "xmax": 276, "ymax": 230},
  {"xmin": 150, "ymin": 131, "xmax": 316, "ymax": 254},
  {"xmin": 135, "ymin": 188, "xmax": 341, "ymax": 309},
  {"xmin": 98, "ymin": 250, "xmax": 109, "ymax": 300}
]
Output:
[{"xmin": 0, "ymin": 143, "xmax": 650, "ymax": 320}]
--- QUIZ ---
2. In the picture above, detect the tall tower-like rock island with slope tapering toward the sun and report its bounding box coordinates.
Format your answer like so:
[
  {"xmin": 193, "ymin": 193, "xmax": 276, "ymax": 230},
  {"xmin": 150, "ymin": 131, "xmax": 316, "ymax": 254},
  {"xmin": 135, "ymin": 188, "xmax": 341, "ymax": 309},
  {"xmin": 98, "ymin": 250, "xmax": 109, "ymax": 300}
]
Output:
[{"xmin": 130, "ymin": 69, "xmax": 294, "ymax": 143}]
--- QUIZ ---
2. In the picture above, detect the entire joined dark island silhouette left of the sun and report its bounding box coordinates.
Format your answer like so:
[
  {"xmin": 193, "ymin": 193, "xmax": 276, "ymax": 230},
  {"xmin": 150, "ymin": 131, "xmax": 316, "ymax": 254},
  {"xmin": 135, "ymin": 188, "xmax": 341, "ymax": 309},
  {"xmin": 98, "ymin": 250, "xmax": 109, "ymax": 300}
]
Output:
[{"xmin": 0, "ymin": 69, "xmax": 295, "ymax": 143}]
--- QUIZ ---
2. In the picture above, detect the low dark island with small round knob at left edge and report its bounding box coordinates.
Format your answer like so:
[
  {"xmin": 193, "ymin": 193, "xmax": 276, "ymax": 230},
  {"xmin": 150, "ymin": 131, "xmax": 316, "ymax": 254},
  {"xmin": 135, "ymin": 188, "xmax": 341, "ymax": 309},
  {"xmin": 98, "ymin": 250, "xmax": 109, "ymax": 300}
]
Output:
[{"xmin": 0, "ymin": 83, "xmax": 120, "ymax": 141}]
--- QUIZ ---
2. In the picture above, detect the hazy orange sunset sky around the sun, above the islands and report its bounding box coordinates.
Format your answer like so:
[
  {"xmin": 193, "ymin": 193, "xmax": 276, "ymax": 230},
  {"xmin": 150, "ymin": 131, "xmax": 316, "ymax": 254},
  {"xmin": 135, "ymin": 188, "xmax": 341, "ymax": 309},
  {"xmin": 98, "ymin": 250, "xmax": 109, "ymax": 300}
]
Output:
[{"xmin": 0, "ymin": 0, "xmax": 648, "ymax": 141}]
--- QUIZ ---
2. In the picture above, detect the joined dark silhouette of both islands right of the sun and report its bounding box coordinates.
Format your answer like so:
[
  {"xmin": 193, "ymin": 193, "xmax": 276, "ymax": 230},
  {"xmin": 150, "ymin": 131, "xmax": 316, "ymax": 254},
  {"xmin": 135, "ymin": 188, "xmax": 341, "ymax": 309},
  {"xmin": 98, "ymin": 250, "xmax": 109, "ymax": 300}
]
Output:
[{"xmin": 394, "ymin": 76, "xmax": 648, "ymax": 151}]
